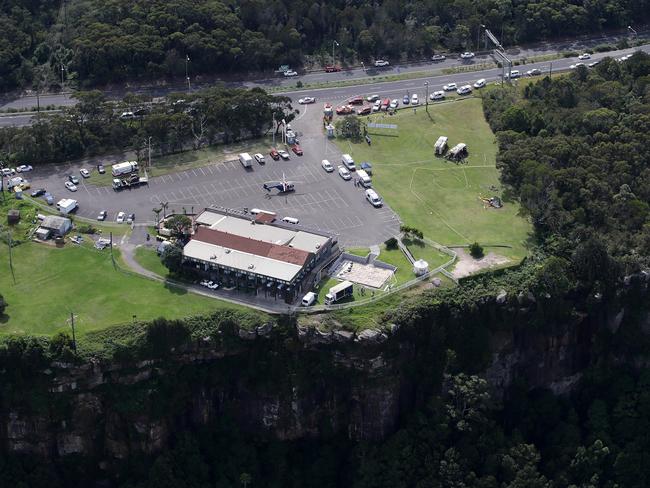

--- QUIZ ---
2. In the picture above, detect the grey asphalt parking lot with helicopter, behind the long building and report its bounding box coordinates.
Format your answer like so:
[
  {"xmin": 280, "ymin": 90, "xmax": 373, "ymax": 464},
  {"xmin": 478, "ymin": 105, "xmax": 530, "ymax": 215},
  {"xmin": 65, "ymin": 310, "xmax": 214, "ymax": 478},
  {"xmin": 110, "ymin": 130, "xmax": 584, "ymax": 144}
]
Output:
[{"xmin": 28, "ymin": 129, "xmax": 399, "ymax": 246}]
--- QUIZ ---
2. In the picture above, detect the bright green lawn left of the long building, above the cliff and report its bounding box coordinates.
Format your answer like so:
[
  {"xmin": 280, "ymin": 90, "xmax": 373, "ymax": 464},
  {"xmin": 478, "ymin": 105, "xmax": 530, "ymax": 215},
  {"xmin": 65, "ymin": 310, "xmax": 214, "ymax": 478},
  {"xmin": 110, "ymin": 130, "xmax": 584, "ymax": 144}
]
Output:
[{"xmin": 0, "ymin": 242, "xmax": 235, "ymax": 335}]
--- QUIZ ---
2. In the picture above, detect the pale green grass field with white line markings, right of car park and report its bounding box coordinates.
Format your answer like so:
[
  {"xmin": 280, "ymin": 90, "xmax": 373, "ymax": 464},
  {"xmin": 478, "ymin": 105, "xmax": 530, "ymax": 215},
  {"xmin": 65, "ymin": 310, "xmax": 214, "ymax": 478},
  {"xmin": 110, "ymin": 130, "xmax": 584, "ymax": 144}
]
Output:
[{"xmin": 337, "ymin": 98, "xmax": 530, "ymax": 260}]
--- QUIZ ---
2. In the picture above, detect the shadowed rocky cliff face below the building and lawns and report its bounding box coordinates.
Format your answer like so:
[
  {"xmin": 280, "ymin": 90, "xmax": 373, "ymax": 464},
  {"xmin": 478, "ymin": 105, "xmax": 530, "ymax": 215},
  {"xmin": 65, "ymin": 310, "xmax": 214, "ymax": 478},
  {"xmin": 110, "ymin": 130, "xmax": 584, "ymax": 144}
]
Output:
[{"xmin": 0, "ymin": 284, "xmax": 644, "ymax": 468}]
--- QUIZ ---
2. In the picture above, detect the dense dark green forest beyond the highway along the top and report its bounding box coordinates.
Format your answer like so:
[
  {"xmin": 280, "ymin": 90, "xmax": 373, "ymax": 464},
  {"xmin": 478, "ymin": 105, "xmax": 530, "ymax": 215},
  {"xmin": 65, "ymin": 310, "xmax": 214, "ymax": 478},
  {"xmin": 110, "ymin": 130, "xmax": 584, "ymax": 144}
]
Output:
[{"xmin": 0, "ymin": 0, "xmax": 650, "ymax": 90}]
